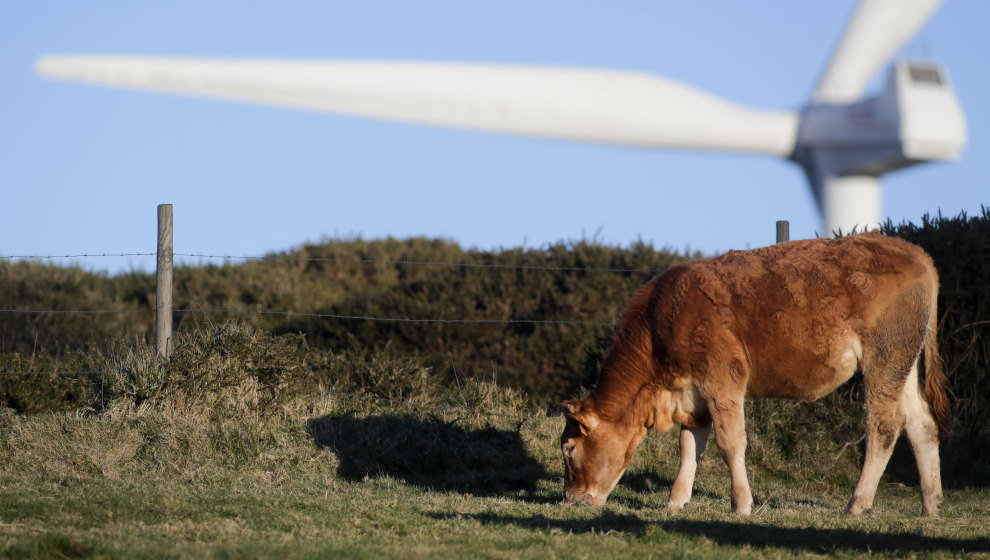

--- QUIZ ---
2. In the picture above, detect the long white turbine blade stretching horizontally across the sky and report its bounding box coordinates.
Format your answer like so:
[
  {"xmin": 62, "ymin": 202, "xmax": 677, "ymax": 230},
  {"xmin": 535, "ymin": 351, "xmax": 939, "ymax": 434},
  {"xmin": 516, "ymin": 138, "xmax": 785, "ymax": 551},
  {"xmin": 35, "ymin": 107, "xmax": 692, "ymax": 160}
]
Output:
[{"xmin": 37, "ymin": 56, "xmax": 798, "ymax": 156}]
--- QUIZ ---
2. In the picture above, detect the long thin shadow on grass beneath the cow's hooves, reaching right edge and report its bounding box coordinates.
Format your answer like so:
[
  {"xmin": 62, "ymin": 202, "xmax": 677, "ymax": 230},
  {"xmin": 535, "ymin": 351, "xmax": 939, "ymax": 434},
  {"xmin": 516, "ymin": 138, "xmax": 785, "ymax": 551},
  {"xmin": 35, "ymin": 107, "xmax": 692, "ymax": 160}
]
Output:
[{"xmin": 440, "ymin": 511, "xmax": 990, "ymax": 554}]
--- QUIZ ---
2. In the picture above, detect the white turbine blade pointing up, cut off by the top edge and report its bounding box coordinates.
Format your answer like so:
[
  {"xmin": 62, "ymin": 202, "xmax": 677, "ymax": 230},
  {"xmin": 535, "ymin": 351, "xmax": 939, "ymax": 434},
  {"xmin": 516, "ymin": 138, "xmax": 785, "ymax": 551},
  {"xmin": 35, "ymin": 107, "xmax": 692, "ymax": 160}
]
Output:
[{"xmin": 811, "ymin": 0, "xmax": 942, "ymax": 103}]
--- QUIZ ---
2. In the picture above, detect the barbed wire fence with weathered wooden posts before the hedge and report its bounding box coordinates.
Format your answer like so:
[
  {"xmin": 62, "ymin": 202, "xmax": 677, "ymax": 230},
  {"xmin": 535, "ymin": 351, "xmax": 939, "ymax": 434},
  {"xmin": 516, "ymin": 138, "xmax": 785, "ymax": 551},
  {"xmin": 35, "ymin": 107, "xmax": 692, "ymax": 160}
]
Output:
[{"xmin": 0, "ymin": 204, "xmax": 789, "ymax": 382}]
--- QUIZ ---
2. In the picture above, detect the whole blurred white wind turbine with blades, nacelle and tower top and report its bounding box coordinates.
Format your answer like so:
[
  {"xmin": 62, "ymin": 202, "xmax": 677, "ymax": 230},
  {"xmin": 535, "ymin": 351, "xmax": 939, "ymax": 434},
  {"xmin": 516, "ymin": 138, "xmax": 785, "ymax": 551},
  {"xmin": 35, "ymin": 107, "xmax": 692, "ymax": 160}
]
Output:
[{"xmin": 37, "ymin": 0, "xmax": 966, "ymax": 232}]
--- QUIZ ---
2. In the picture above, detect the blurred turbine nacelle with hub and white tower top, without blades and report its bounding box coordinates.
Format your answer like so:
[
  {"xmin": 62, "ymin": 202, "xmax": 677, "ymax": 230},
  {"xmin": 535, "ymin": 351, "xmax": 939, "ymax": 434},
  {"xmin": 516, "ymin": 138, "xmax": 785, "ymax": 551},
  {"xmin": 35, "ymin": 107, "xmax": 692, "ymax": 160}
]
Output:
[{"xmin": 791, "ymin": 61, "xmax": 966, "ymax": 233}]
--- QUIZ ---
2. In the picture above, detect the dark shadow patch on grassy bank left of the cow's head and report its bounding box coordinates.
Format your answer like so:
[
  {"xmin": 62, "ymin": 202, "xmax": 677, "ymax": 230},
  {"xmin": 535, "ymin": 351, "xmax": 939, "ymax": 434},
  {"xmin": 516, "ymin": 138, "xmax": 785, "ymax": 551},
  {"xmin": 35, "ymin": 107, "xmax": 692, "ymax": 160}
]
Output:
[{"xmin": 306, "ymin": 415, "xmax": 547, "ymax": 501}]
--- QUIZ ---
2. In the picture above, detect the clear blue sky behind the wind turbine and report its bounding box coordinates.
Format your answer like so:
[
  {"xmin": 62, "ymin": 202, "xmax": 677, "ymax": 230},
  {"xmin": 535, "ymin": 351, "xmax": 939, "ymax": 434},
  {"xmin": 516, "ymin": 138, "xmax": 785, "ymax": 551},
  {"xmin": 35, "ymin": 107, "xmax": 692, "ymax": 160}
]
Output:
[{"xmin": 0, "ymin": 0, "xmax": 990, "ymax": 272}]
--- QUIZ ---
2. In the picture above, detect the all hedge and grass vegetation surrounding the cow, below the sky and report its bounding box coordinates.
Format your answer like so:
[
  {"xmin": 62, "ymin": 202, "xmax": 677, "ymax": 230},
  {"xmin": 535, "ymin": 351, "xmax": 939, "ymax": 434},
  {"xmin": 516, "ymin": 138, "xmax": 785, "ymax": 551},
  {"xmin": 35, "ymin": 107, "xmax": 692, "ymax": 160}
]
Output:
[{"xmin": 0, "ymin": 209, "xmax": 990, "ymax": 558}]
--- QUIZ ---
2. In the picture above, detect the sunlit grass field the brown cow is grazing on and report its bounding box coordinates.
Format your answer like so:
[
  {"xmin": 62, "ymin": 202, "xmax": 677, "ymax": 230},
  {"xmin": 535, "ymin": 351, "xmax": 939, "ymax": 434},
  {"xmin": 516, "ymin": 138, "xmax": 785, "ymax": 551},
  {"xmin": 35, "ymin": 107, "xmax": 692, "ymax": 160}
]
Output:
[{"xmin": 0, "ymin": 382, "xmax": 990, "ymax": 560}]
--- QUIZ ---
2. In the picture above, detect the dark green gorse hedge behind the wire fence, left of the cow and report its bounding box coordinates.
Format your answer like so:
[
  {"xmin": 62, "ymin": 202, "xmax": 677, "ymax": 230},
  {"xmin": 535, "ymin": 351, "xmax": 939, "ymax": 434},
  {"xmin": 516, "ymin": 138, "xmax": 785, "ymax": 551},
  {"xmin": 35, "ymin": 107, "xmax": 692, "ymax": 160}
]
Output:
[{"xmin": 0, "ymin": 239, "xmax": 697, "ymax": 398}]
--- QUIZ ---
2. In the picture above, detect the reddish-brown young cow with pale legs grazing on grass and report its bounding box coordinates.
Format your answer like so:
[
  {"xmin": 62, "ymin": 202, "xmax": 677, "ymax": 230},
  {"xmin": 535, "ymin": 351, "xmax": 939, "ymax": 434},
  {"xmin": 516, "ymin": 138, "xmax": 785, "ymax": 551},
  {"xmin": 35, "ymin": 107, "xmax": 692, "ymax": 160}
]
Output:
[{"xmin": 561, "ymin": 233, "xmax": 948, "ymax": 516}]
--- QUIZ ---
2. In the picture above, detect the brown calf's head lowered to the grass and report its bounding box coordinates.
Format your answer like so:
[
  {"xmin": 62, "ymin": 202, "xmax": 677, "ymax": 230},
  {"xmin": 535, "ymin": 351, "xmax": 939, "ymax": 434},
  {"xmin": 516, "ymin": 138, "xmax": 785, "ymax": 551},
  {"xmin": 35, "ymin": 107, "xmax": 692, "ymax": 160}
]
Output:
[{"xmin": 560, "ymin": 399, "xmax": 646, "ymax": 506}]
